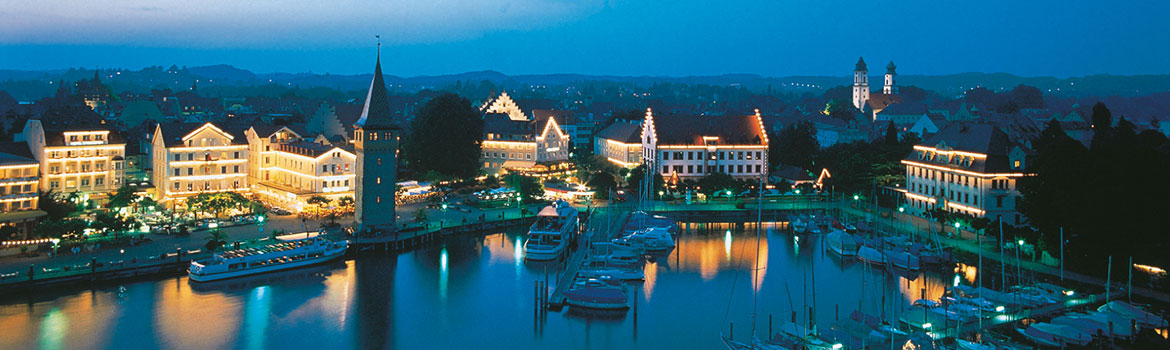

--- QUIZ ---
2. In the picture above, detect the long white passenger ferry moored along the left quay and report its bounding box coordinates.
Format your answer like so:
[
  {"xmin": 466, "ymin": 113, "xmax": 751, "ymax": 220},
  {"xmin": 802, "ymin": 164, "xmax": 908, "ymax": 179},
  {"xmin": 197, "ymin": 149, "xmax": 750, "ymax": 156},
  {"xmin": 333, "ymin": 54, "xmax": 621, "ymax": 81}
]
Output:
[{"xmin": 187, "ymin": 232, "xmax": 349, "ymax": 282}]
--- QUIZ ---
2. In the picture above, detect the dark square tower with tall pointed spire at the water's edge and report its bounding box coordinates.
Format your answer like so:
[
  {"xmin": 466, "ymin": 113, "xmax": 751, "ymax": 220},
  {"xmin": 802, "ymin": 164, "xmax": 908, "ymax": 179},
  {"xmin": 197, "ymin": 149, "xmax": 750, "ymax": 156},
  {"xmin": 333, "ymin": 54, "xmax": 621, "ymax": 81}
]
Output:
[{"xmin": 353, "ymin": 43, "xmax": 399, "ymax": 238}]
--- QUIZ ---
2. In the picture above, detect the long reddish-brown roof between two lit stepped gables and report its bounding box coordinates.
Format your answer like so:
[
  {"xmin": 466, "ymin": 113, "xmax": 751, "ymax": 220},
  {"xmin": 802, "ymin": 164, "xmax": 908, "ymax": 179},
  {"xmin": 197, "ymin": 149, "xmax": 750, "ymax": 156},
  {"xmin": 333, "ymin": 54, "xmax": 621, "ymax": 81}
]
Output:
[{"xmin": 648, "ymin": 111, "xmax": 768, "ymax": 145}]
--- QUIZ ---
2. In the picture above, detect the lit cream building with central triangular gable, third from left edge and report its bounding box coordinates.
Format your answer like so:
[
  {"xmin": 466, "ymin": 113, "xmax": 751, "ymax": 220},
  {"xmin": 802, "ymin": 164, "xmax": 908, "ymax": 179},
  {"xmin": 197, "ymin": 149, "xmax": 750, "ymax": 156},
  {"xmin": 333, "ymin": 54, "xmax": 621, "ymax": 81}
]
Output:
[{"xmin": 151, "ymin": 123, "xmax": 249, "ymax": 200}]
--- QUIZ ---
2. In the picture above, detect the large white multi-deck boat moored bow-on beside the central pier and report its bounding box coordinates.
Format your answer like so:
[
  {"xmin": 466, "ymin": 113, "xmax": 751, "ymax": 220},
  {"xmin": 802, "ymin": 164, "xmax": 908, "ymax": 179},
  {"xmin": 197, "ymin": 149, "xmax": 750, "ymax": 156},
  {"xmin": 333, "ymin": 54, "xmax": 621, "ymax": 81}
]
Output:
[{"xmin": 524, "ymin": 200, "xmax": 579, "ymax": 260}]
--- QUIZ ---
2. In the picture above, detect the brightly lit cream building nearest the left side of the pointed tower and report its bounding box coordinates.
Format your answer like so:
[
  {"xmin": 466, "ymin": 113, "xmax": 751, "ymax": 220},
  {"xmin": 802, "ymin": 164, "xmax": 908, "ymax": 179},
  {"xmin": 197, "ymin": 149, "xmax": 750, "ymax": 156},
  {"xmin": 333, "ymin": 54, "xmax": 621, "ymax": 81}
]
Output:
[{"xmin": 245, "ymin": 126, "xmax": 357, "ymax": 212}]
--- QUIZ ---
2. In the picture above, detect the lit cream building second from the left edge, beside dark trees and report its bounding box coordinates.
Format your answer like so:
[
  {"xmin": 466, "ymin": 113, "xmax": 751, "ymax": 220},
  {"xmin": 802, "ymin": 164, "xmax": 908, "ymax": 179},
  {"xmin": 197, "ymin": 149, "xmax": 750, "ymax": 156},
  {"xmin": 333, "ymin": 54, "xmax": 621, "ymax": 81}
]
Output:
[{"xmin": 23, "ymin": 118, "xmax": 126, "ymax": 199}]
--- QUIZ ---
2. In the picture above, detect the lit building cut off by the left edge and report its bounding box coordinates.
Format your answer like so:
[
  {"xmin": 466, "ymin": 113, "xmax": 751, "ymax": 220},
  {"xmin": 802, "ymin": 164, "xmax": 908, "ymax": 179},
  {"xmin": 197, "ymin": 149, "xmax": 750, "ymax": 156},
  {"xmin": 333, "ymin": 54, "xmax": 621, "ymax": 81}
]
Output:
[{"xmin": 0, "ymin": 143, "xmax": 46, "ymax": 239}]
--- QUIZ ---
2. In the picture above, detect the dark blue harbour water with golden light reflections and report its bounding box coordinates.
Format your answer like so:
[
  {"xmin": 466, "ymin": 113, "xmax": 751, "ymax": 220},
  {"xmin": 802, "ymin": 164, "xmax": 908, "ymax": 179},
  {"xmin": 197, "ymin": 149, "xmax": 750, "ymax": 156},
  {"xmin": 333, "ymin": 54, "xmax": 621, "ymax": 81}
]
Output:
[{"xmin": 0, "ymin": 222, "xmax": 959, "ymax": 349}]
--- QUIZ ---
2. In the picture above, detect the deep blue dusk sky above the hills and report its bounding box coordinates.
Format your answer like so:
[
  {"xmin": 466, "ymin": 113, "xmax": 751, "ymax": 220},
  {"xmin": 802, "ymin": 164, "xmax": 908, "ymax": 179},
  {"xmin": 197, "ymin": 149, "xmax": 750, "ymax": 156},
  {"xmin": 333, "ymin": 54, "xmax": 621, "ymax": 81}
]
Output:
[{"xmin": 0, "ymin": 0, "xmax": 1170, "ymax": 76}]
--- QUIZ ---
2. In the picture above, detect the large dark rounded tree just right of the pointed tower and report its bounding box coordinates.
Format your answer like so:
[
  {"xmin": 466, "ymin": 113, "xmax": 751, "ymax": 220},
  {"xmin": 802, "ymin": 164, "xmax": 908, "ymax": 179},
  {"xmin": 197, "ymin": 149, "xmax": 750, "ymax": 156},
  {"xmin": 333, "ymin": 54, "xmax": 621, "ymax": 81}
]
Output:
[{"xmin": 404, "ymin": 94, "xmax": 483, "ymax": 178}]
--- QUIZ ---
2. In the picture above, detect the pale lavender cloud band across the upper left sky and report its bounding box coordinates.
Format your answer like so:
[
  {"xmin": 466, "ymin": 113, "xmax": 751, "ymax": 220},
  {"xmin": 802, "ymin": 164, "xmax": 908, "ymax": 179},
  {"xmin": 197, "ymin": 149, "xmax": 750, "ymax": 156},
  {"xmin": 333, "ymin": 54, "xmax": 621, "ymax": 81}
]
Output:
[{"xmin": 0, "ymin": 0, "xmax": 605, "ymax": 48}]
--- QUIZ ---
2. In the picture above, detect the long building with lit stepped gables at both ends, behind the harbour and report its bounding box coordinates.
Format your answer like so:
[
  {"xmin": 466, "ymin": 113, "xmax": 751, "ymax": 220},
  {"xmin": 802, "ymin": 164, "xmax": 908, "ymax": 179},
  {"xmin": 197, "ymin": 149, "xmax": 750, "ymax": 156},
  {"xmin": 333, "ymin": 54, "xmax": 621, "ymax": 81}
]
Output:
[{"xmin": 642, "ymin": 109, "xmax": 768, "ymax": 179}]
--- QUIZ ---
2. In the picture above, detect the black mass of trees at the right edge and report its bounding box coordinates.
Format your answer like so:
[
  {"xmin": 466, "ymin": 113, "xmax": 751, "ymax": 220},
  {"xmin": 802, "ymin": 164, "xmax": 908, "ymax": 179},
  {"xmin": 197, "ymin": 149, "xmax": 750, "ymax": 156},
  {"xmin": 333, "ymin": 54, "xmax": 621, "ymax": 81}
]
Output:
[{"xmin": 1019, "ymin": 103, "xmax": 1170, "ymax": 271}]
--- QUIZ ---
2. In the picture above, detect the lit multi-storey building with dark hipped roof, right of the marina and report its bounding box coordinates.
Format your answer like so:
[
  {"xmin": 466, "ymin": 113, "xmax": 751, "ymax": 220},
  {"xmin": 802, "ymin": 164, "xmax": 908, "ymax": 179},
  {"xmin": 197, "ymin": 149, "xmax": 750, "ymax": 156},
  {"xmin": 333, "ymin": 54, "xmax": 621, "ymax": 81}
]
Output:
[{"xmin": 902, "ymin": 123, "xmax": 1034, "ymax": 225}]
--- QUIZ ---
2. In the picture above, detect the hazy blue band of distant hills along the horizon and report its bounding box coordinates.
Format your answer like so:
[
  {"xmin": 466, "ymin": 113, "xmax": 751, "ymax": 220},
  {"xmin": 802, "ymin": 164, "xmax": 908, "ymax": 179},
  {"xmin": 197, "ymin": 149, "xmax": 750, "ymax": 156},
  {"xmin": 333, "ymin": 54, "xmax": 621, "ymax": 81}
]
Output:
[{"xmin": 0, "ymin": 64, "xmax": 1170, "ymax": 101}]
